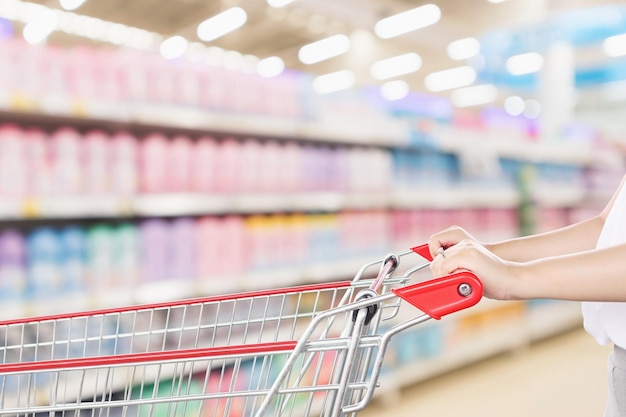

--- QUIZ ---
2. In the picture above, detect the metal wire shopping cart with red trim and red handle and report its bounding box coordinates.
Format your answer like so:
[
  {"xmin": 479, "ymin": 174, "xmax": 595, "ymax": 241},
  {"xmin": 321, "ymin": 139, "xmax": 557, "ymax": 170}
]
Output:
[{"xmin": 0, "ymin": 245, "xmax": 482, "ymax": 417}]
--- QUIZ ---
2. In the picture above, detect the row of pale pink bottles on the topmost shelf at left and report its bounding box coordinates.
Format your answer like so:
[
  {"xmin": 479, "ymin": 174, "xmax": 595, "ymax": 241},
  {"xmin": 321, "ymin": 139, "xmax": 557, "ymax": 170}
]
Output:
[{"xmin": 0, "ymin": 37, "xmax": 302, "ymax": 118}]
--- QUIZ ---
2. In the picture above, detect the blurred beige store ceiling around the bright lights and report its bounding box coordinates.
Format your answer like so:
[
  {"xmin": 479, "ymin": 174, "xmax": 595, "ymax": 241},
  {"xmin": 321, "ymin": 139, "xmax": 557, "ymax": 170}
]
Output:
[{"xmin": 9, "ymin": 0, "xmax": 620, "ymax": 130}]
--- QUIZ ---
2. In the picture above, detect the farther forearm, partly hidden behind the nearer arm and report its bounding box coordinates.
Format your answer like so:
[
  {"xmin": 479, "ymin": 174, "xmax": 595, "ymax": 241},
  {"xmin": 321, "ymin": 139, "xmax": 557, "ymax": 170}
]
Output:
[{"xmin": 485, "ymin": 216, "xmax": 603, "ymax": 262}]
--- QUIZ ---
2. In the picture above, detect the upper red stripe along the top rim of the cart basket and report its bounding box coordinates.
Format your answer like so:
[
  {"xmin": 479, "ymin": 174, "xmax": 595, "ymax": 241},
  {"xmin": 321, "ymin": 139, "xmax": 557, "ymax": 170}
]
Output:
[{"xmin": 0, "ymin": 281, "xmax": 352, "ymax": 326}]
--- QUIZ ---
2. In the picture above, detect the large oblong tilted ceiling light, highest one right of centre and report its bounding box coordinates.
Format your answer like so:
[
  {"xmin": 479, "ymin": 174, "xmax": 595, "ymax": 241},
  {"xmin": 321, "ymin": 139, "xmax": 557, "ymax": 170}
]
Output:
[{"xmin": 374, "ymin": 4, "xmax": 441, "ymax": 39}]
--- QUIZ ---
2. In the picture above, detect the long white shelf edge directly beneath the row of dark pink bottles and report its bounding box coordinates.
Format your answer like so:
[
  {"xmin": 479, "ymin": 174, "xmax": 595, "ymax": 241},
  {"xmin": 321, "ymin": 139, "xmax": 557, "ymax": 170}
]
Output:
[{"xmin": 0, "ymin": 185, "xmax": 587, "ymax": 220}]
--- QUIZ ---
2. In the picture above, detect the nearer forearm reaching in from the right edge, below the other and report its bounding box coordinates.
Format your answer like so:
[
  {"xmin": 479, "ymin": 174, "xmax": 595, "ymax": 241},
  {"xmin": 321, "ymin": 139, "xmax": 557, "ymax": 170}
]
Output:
[{"xmin": 510, "ymin": 244, "xmax": 626, "ymax": 301}]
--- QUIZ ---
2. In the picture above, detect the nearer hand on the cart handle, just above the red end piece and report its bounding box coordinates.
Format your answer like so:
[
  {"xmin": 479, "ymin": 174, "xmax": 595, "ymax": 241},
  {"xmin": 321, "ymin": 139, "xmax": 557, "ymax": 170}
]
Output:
[{"xmin": 430, "ymin": 237, "xmax": 522, "ymax": 300}]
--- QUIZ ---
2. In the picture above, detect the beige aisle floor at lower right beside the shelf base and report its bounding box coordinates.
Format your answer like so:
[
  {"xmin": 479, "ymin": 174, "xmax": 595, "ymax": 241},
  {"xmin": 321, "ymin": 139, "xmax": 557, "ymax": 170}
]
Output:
[{"xmin": 359, "ymin": 330, "xmax": 611, "ymax": 417}]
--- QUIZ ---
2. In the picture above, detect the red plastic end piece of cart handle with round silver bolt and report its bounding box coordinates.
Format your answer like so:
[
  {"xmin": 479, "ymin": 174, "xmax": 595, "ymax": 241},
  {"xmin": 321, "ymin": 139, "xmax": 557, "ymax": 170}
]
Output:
[{"xmin": 392, "ymin": 271, "xmax": 483, "ymax": 320}]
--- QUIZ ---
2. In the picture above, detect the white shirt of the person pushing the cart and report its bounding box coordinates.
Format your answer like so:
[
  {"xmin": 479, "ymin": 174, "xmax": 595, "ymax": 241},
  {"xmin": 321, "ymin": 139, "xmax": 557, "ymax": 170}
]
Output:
[{"xmin": 582, "ymin": 182, "xmax": 626, "ymax": 349}]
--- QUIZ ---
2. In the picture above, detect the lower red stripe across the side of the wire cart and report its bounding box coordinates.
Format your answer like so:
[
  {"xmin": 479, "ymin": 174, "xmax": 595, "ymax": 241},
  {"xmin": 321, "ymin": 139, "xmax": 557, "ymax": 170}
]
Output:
[{"xmin": 0, "ymin": 340, "xmax": 297, "ymax": 374}]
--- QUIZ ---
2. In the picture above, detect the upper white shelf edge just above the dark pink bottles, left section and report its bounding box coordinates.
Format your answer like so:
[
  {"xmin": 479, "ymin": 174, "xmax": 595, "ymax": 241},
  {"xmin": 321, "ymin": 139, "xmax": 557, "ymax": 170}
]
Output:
[{"xmin": 0, "ymin": 103, "xmax": 410, "ymax": 147}]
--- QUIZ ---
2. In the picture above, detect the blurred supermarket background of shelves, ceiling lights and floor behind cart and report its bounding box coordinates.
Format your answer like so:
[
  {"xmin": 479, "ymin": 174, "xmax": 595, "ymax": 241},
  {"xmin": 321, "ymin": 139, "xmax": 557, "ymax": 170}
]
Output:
[{"xmin": 0, "ymin": 0, "xmax": 626, "ymax": 416}]
